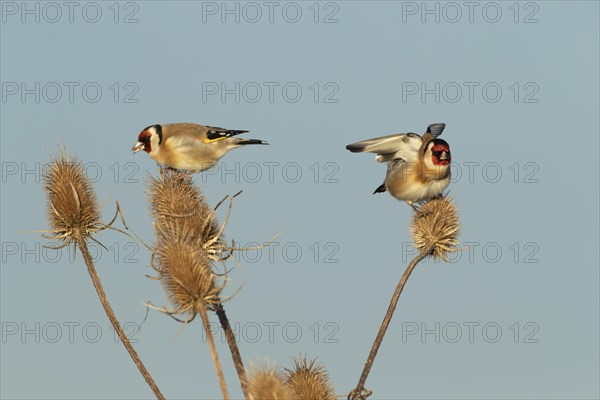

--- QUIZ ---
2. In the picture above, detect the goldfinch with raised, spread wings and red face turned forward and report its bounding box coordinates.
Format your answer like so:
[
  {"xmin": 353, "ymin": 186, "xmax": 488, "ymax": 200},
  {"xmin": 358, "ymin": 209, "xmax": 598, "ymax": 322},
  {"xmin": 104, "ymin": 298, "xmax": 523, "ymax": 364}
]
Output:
[{"xmin": 346, "ymin": 124, "xmax": 451, "ymax": 210}]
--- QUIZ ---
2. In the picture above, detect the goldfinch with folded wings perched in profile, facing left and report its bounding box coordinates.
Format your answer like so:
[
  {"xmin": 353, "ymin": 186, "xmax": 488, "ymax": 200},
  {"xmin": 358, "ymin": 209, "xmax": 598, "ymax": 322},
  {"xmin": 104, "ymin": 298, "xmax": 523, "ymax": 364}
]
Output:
[{"xmin": 131, "ymin": 123, "xmax": 268, "ymax": 172}]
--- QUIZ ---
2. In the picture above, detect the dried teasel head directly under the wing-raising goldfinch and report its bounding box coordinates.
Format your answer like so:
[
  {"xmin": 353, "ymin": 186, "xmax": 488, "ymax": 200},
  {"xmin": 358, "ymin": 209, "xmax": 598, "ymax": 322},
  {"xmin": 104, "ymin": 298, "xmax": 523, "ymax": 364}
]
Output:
[{"xmin": 411, "ymin": 196, "xmax": 460, "ymax": 261}]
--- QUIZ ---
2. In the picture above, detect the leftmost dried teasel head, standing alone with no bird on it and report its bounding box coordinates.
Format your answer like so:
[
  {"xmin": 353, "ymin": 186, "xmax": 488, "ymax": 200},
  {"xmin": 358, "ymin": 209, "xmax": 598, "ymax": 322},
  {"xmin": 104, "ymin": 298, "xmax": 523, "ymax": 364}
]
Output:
[{"xmin": 44, "ymin": 147, "xmax": 104, "ymax": 245}]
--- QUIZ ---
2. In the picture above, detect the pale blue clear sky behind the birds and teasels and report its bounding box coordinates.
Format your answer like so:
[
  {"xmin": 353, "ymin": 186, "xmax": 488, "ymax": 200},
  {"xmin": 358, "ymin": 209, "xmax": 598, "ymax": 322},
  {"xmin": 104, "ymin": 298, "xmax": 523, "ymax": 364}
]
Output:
[{"xmin": 0, "ymin": 1, "xmax": 600, "ymax": 399}]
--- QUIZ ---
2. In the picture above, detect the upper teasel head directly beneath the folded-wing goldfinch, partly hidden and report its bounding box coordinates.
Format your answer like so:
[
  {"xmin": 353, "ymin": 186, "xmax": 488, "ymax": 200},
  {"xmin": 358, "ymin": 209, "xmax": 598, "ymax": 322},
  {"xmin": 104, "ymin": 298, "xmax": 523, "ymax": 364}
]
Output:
[{"xmin": 147, "ymin": 169, "xmax": 225, "ymax": 255}]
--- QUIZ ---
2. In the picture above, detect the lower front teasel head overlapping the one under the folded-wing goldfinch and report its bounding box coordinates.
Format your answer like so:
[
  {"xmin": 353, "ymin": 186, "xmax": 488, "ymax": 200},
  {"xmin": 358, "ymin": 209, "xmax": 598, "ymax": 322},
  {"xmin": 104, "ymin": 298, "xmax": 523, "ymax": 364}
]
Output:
[{"xmin": 153, "ymin": 224, "xmax": 223, "ymax": 316}]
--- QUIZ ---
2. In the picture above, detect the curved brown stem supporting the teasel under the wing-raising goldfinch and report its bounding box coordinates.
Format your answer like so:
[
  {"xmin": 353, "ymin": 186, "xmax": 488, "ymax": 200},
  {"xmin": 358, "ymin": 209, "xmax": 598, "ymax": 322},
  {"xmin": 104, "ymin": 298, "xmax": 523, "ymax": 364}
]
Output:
[{"xmin": 348, "ymin": 246, "xmax": 433, "ymax": 400}]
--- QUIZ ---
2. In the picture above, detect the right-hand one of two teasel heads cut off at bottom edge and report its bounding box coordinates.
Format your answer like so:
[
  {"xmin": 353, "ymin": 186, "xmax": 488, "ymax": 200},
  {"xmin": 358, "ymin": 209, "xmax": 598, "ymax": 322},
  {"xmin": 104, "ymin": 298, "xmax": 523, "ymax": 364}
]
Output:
[{"xmin": 285, "ymin": 356, "xmax": 337, "ymax": 400}]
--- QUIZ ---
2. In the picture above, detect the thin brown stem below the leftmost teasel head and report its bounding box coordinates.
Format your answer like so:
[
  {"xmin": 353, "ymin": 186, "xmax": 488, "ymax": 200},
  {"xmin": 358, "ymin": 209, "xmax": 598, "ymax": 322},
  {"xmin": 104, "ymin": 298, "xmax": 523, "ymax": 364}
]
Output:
[{"xmin": 76, "ymin": 236, "xmax": 165, "ymax": 400}]
